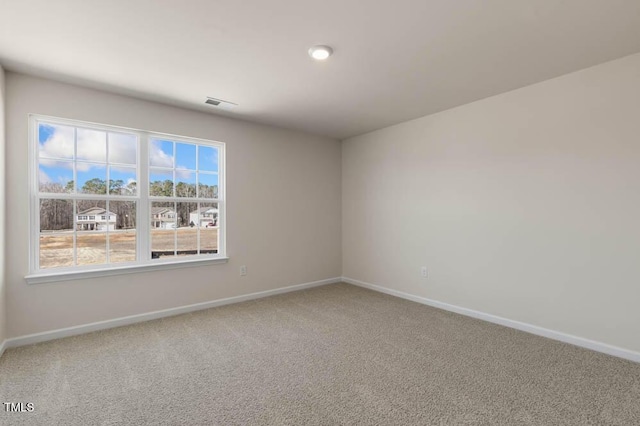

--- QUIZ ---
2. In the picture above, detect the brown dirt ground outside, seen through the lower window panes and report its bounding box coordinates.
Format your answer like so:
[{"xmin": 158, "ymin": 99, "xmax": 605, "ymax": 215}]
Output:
[{"xmin": 40, "ymin": 228, "xmax": 218, "ymax": 268}]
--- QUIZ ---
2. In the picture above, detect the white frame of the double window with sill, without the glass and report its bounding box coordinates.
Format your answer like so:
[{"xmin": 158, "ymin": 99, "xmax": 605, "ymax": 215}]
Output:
[{"xmin": 25, "ymin": 114, "xmax": 228, "ymax": 284}]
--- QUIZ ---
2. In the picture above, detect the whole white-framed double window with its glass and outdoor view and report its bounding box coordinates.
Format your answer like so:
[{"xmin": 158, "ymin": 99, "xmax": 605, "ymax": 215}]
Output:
[{"xmin": 28, "ymin": 116, "xmax": 225, "ymax": 278}]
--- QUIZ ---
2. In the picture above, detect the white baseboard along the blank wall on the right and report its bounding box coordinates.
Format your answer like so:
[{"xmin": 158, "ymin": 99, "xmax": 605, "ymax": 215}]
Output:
[{"xmin": 342, "ymin": 277, "xmax": 640, "ymax": 363}]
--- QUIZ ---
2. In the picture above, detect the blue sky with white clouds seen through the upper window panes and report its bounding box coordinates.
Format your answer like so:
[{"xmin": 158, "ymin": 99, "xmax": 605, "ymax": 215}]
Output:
[{"xmin": 38, "ymin": 122, "xmax": 218, "ymax": 195}]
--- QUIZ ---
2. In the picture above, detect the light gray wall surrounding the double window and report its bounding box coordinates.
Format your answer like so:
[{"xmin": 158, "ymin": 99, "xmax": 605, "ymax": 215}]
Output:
[{"xmin": 6, "ymin": 72, "xmax": 341, "ymax": 337}]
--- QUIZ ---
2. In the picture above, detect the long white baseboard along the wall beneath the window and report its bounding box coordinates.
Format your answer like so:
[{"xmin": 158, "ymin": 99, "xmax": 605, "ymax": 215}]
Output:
[{"xmin": 0, "ymin": 277, "xmax": 342, "ymax": 356}]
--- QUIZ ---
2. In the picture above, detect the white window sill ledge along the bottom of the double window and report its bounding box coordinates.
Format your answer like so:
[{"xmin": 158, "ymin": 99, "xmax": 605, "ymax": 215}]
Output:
[{"xmin": 24, "ymin": 257, "xmax": 229, "ymax": 284}]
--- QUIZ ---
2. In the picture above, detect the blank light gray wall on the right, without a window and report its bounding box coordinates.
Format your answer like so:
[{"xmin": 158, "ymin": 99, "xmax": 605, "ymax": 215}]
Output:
[{"xmin": 342, "ymin": 54, "xmax": 640, "ymax": 351}]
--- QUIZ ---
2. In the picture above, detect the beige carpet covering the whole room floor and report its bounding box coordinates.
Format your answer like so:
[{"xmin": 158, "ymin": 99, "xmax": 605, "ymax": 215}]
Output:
[{"xmin": 0, "ymin": 284, "xmax": 640, "ymax": 426}]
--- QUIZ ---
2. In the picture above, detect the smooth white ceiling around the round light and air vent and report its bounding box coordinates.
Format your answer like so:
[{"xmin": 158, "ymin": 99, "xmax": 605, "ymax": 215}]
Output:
[{"xmin": 0, "ymin": 0, "xmax": 640, "ymax": 139}]
